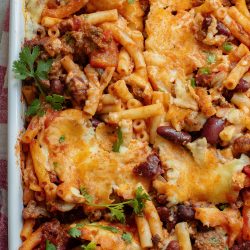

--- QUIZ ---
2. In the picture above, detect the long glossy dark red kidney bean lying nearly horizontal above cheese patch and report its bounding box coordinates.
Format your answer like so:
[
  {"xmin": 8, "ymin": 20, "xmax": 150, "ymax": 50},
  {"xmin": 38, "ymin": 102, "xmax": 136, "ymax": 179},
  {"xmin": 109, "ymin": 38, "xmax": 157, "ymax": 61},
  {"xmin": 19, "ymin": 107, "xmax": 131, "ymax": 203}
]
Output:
[{"xmin": 157, "ymin": 126, "xmax": 192, "ymax": 145}]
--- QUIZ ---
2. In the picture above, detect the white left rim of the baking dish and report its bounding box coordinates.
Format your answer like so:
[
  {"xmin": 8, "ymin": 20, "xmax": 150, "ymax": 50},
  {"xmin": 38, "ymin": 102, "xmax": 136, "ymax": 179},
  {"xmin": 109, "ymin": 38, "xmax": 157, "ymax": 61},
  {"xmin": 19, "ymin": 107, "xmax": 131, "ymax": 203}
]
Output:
[{"xmin": 8, "ymin": 0, "xmax": 24, "ymax": 250}]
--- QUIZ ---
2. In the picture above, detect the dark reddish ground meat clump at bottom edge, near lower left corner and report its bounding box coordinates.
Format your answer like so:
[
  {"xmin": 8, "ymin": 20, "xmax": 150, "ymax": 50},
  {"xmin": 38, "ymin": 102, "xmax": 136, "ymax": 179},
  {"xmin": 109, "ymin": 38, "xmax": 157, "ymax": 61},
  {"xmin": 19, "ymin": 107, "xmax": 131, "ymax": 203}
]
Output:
[{"xmin": 38, "ymin": 220, "xmax": 69, "ymax": 250}]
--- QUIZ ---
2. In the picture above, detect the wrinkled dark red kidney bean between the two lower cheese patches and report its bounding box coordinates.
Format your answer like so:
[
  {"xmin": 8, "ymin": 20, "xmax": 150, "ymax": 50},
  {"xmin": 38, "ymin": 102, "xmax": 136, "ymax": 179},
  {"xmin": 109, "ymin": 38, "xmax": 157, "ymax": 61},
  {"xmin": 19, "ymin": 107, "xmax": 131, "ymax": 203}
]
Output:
[{"xmin": 133, "ymin": 154, "xmax": 164, "ymax": 178}]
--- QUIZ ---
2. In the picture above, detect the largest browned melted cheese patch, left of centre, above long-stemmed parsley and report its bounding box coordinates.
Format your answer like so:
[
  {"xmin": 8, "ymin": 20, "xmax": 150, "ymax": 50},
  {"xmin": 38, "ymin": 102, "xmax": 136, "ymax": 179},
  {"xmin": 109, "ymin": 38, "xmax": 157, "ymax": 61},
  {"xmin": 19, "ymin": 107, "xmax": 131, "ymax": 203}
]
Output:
[{"xmin": 32, "ymin": 110, "xmax": 150, "ymax": 203}]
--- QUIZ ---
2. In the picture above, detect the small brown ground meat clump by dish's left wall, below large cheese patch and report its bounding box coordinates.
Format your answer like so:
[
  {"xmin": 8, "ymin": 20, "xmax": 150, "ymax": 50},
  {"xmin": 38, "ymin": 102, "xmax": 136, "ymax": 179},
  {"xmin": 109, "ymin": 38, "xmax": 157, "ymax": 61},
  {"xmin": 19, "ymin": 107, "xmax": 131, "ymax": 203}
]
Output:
[{"xmin": 23, "ymin": 200, "xmax": 49, "ymax": 220}]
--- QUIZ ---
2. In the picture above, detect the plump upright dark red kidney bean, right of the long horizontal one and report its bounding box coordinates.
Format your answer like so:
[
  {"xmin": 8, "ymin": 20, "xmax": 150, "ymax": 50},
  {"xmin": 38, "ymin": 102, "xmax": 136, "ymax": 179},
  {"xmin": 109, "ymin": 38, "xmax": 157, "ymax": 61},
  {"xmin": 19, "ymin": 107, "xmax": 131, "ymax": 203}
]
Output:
[{"xmin": 201, "ymin": 117, "xmax": 225, "ymax": 144}]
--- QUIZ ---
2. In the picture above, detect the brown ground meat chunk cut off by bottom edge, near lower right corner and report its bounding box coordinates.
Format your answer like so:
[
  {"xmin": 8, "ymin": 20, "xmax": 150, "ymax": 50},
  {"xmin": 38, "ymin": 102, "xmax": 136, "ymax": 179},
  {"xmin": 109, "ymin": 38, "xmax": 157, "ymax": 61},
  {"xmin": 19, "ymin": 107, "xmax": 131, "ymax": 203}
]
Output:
[{"xmin": 194, "ymin": 230, "xmax": 227, "ymax": 250}]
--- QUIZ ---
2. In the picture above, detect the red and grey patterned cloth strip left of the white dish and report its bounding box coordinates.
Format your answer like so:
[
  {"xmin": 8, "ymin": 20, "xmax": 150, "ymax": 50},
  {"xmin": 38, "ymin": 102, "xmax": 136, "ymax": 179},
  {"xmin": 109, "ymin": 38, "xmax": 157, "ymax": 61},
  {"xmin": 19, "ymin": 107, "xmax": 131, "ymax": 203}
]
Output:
[{"xmin": 0, "ymin": 0, "xmax": 9, "ymax": 250}]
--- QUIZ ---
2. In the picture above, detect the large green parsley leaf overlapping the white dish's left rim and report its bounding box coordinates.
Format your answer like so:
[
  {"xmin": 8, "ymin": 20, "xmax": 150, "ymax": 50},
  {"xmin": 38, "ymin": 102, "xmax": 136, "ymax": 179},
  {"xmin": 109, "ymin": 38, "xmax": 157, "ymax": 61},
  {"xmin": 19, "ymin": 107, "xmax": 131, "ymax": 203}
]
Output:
[{"xmin": 13, "ymin": 46, "xmax": 52, "ymax": 95}]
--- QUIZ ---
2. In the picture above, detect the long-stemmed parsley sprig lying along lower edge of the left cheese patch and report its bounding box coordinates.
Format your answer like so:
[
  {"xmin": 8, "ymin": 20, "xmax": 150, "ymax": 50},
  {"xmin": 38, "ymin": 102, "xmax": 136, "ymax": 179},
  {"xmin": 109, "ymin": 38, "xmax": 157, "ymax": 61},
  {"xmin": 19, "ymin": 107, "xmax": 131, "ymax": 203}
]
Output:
[{"xmin": 84, "ymin": 186, "xmax": 150, "ymax": 223}]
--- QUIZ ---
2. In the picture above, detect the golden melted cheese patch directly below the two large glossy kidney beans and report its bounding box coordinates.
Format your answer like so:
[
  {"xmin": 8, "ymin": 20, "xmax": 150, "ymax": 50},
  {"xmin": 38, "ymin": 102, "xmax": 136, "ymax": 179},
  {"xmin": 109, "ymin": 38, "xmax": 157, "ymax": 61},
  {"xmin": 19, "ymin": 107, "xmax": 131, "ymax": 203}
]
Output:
[{"xmin": 154, "ymin": 137, "xmax": 249, "ymax": 204}]
